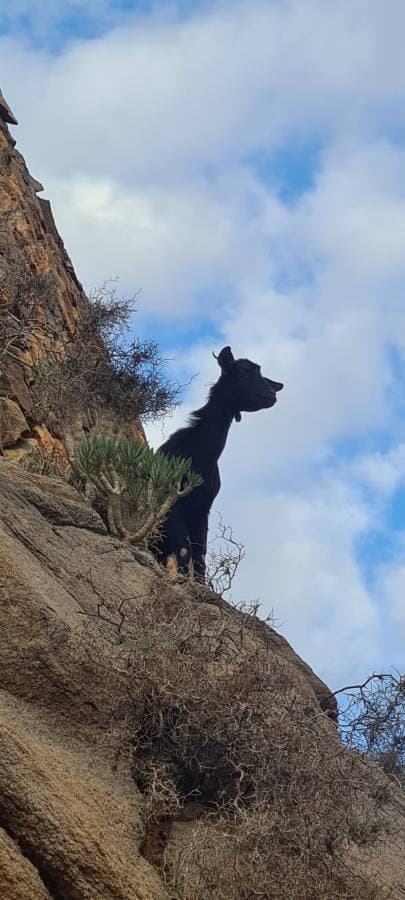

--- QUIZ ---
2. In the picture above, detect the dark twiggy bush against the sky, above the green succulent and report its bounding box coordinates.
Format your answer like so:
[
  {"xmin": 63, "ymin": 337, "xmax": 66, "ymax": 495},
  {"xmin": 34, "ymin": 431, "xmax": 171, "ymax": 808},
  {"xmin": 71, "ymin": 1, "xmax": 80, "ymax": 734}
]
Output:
[{"xmin": 32, "ymin": 283, "xmax": 179, "ymax": 436}]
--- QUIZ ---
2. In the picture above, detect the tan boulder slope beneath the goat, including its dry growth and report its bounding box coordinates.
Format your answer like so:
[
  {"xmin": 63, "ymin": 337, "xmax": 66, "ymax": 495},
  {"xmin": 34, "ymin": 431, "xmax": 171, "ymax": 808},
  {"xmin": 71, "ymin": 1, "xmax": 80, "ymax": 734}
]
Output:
[{"xmin": 0, "ymin": 461, "xmax": 405, "ymax": 900}]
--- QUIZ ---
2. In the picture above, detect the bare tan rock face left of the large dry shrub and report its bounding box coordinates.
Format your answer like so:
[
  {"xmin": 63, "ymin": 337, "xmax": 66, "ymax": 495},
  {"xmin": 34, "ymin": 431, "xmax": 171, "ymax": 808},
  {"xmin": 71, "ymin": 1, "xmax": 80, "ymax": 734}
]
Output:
[{"xmin": 0, "ymin": 462, "xmax": 165, "ymax": 900}]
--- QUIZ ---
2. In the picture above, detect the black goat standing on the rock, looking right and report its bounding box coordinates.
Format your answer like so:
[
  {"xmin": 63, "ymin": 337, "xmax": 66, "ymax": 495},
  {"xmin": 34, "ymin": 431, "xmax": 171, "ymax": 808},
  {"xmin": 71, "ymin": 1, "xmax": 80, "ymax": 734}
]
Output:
[{"xmin": 156, "ymin": 347, "xmax": 283, "ymax": 581}]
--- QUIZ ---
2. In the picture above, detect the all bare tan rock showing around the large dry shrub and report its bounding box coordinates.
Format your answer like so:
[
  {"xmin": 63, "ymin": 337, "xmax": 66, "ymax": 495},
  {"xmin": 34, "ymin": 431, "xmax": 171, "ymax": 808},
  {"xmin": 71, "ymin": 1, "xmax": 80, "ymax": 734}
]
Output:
[{"xmin": 0, "ymin": 460, "xmax": 405, "ymax": 900}]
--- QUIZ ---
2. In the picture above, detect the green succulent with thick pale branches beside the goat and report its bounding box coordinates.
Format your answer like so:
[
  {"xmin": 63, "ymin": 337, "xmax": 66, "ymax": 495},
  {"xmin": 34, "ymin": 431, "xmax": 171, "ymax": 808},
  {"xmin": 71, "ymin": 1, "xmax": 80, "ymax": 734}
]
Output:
[{"xmin": 65, "ymin": 436, "xmax": 202, "ymax": 544}]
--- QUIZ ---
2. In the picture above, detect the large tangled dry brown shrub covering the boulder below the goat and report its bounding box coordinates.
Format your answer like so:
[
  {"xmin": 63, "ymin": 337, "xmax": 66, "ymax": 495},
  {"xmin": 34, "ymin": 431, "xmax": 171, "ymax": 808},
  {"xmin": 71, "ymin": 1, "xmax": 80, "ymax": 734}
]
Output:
[{"xmin": 76, "ymin": 577, "xmax": 391, "ymax": 900}]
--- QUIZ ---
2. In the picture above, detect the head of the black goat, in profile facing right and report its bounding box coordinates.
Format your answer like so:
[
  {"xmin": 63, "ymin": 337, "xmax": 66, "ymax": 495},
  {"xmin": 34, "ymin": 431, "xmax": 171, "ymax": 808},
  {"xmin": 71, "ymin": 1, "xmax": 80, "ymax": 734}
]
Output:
[{"xmin": 214, "ymin": 347, "xmax": 283, "ymax": 422}]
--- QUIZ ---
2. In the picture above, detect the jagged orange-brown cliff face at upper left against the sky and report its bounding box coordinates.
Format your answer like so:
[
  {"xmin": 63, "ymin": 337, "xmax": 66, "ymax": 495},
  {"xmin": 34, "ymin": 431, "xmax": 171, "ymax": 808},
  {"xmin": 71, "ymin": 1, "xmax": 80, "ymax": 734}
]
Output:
[{"xmin": 0, "ymin": 93, "xmax": 145, "ymax": 460}]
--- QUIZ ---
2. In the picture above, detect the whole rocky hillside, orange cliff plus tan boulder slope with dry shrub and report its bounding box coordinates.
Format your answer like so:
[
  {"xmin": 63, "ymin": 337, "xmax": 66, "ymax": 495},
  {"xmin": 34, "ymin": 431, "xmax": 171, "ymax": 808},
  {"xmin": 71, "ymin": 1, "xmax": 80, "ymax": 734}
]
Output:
[{"xmin": 0, "ymin": 86, "xmax": 405, "ymax": 900}]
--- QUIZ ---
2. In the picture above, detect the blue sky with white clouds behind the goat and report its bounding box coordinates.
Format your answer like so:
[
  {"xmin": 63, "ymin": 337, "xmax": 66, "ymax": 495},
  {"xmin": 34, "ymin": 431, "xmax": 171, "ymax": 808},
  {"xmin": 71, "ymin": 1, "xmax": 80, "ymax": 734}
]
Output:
[{"xmin": 0, "ymin": 0, "xmax": 405, "ymax": 687}]
